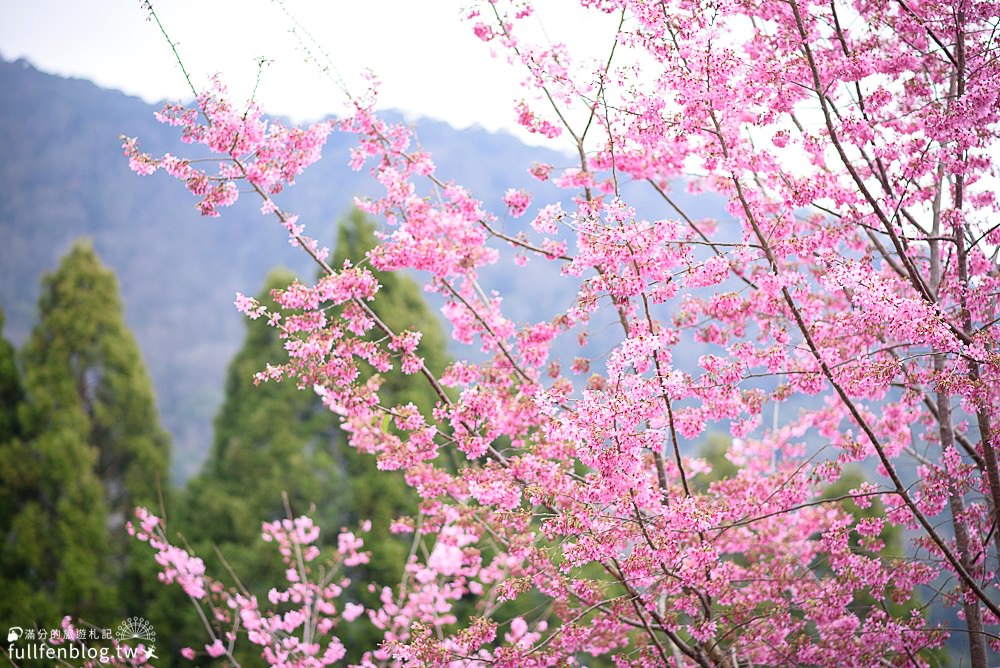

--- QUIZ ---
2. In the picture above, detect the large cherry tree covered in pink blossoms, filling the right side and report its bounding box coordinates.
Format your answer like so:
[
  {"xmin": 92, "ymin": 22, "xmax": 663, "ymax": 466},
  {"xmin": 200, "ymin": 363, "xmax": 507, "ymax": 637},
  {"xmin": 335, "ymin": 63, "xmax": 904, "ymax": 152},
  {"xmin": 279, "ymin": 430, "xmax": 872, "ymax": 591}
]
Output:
[{"xmin": 124, "ymin": 0, "xmax": 1000, "ymax": 668}]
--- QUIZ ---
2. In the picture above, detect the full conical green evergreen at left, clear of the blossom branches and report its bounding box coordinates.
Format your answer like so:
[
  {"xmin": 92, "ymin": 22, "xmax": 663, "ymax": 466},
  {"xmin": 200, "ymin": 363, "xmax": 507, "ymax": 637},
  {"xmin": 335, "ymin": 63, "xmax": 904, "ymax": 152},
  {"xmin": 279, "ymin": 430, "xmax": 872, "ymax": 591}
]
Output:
[{"xmin": 0, "ymin": 243, "xmax": 169, "ymax": 627}]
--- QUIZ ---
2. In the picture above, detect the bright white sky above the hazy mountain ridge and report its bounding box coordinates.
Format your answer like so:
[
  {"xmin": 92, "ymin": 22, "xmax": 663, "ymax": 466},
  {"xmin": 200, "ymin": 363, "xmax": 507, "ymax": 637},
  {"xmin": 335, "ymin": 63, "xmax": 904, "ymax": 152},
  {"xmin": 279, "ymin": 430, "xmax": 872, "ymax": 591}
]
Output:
[{"xmin": 0, "ymin": 0, "xmax": 617, "ymax": 142}]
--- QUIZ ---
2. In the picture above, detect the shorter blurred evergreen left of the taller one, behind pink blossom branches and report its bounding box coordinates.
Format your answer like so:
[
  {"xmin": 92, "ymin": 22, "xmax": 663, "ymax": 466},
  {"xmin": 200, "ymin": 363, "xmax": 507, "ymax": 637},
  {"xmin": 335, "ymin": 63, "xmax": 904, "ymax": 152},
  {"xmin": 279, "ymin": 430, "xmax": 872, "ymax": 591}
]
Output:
[{"xmin": 181, "ymin": 270, "xmax": 342, "ymax": 588}]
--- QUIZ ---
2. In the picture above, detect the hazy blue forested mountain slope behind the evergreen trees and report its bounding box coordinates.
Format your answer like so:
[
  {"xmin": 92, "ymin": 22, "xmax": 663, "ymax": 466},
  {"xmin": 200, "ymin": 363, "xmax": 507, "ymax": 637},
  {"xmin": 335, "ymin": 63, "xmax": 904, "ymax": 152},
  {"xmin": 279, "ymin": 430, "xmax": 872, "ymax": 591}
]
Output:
[{"xmin": 0, "ymin": 61, "xmax": 592, "ymax": 477}]
